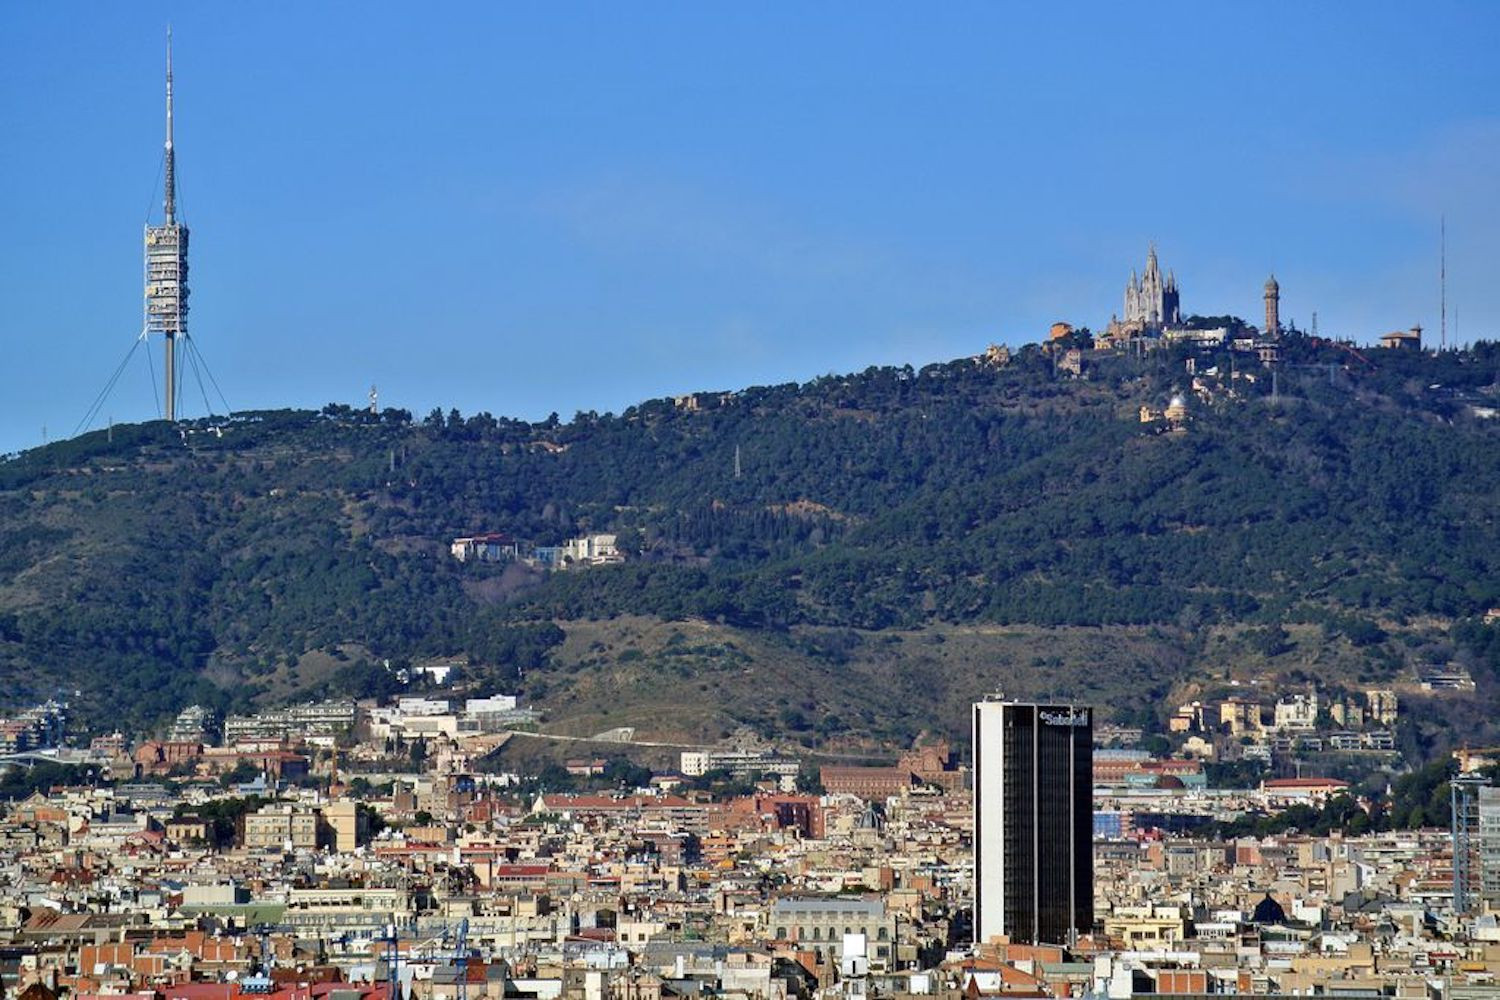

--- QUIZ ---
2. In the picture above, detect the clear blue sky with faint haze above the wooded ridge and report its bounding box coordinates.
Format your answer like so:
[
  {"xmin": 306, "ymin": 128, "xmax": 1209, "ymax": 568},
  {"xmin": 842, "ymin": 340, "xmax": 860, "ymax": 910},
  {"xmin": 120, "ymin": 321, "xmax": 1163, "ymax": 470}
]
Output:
[{"xmin": 0, "ymin": 3, "xmax": 1500, "ymax": 451}]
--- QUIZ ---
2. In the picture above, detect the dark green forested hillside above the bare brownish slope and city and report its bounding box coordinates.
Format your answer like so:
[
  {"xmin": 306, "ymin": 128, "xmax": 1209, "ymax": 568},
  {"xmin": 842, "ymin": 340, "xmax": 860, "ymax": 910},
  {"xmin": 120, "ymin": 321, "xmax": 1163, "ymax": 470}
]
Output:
[{"xmin": 0, "ymin": 337, "xmax": 1500, "ymax": 743}]
